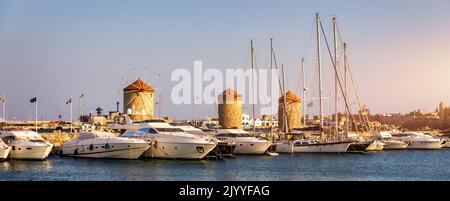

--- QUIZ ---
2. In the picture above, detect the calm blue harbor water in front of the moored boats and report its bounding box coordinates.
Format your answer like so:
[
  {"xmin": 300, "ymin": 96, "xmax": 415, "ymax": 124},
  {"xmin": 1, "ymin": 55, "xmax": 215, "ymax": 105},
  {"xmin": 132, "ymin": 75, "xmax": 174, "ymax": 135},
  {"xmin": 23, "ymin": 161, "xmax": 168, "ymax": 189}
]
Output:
[{"xmin": 0, "ymin": 149, "xmax": 450, "ymax": 181}]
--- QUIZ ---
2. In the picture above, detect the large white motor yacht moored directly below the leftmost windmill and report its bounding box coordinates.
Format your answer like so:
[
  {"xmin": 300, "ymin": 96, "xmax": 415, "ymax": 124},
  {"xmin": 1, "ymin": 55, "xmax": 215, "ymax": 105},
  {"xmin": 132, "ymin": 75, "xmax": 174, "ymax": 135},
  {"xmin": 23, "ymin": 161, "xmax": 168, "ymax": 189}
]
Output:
[{"xmin": 122, "ymin": 122, "xmax": 217, "ymax": 159}]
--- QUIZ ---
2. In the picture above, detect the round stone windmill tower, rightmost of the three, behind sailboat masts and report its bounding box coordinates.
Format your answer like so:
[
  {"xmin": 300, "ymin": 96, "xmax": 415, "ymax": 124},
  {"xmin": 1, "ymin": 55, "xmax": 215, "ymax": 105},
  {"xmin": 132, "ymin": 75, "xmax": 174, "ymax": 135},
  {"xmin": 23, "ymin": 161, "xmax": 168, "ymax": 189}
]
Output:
[{"xmin": 278, "ymin": 91, "xmax": 302, "ymax": 131}]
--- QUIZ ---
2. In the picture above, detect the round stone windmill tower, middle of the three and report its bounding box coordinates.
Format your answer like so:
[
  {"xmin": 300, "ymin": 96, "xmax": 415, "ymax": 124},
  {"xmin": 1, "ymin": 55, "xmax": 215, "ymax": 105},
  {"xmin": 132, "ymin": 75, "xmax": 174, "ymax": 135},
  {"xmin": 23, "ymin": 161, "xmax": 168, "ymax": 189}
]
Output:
[{"xmin": 218, "ymin": 88, "xmax": 242, "ymax": 128}]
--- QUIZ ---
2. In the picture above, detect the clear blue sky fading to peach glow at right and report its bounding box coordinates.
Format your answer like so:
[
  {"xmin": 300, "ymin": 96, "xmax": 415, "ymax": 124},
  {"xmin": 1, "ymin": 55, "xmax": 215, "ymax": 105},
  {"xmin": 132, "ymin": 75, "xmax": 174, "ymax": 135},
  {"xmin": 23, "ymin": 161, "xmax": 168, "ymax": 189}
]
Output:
[{"xmin": 0, "ymin": 0, "xmax": 450, "ymax": 120}]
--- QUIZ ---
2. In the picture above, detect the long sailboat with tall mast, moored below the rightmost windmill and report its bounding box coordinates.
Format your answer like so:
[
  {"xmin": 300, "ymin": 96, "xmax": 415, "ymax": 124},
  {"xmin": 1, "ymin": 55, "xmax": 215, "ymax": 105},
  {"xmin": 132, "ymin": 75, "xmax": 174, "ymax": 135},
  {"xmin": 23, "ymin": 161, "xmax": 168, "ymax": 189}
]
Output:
[{"xmin": 277, "ymin": 13, "xmax": 352, "ymax": 153}]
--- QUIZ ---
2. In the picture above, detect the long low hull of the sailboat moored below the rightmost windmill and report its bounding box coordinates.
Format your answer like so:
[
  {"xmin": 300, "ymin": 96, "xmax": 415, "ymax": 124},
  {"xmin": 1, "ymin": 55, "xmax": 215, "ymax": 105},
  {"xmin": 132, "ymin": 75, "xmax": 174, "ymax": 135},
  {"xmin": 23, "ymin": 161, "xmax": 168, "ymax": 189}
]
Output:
[{"xmin": 276, "ymin": 142, "xmax": 351, "ymax": 153}]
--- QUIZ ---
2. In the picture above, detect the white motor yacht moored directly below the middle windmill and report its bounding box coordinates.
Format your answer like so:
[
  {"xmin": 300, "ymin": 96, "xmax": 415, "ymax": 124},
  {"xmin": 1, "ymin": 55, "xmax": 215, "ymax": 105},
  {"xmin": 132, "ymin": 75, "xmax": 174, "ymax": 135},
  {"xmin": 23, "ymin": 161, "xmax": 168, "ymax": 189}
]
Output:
[{"xmin": 208, "ymin": 129, "xmax": 272, "ymax": 154}]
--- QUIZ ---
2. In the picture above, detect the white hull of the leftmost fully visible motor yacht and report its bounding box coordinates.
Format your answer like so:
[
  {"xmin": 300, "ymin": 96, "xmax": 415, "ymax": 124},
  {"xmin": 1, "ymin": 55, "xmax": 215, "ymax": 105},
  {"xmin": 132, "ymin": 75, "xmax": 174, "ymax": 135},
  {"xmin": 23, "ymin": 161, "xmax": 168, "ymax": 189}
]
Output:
[{"xmin": 8, "ymin": 145, "xmax": 53, "ymax": 160}]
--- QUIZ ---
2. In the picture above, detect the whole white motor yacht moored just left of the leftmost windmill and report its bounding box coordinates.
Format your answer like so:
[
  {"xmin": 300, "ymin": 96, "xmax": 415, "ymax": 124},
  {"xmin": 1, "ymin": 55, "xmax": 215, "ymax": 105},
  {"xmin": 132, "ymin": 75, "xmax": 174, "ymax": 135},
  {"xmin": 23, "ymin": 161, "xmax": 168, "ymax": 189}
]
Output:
[{"xmin": 59, "ymin": 131, "xmax": 150, "ymax": 159}]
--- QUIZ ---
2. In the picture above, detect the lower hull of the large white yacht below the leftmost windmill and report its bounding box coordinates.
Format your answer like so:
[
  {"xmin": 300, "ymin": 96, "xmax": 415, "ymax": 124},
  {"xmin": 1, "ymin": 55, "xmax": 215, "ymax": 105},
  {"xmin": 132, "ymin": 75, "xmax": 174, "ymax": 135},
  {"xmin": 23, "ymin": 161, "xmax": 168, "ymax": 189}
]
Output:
[{"xmin": 142, "ymin": 142, "xmax": 217, "ymax": 159}]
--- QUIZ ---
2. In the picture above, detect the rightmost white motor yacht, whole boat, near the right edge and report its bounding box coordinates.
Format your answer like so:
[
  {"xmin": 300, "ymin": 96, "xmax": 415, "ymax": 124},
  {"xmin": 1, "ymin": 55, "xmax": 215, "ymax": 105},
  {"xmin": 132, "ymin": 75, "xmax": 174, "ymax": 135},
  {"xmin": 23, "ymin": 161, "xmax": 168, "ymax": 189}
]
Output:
[{"xmin": 392, "ymin": 132, "xmax": 445, "ymax": 149}]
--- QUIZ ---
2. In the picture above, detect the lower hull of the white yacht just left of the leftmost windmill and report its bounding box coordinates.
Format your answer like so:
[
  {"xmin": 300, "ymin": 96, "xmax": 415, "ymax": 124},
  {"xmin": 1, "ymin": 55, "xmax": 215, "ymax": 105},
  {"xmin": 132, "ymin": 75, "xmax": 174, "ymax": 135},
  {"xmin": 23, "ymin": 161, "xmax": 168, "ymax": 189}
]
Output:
[{"xmin": 60, "ymin": 143, "xmax": 149, "ymax": 159}]
